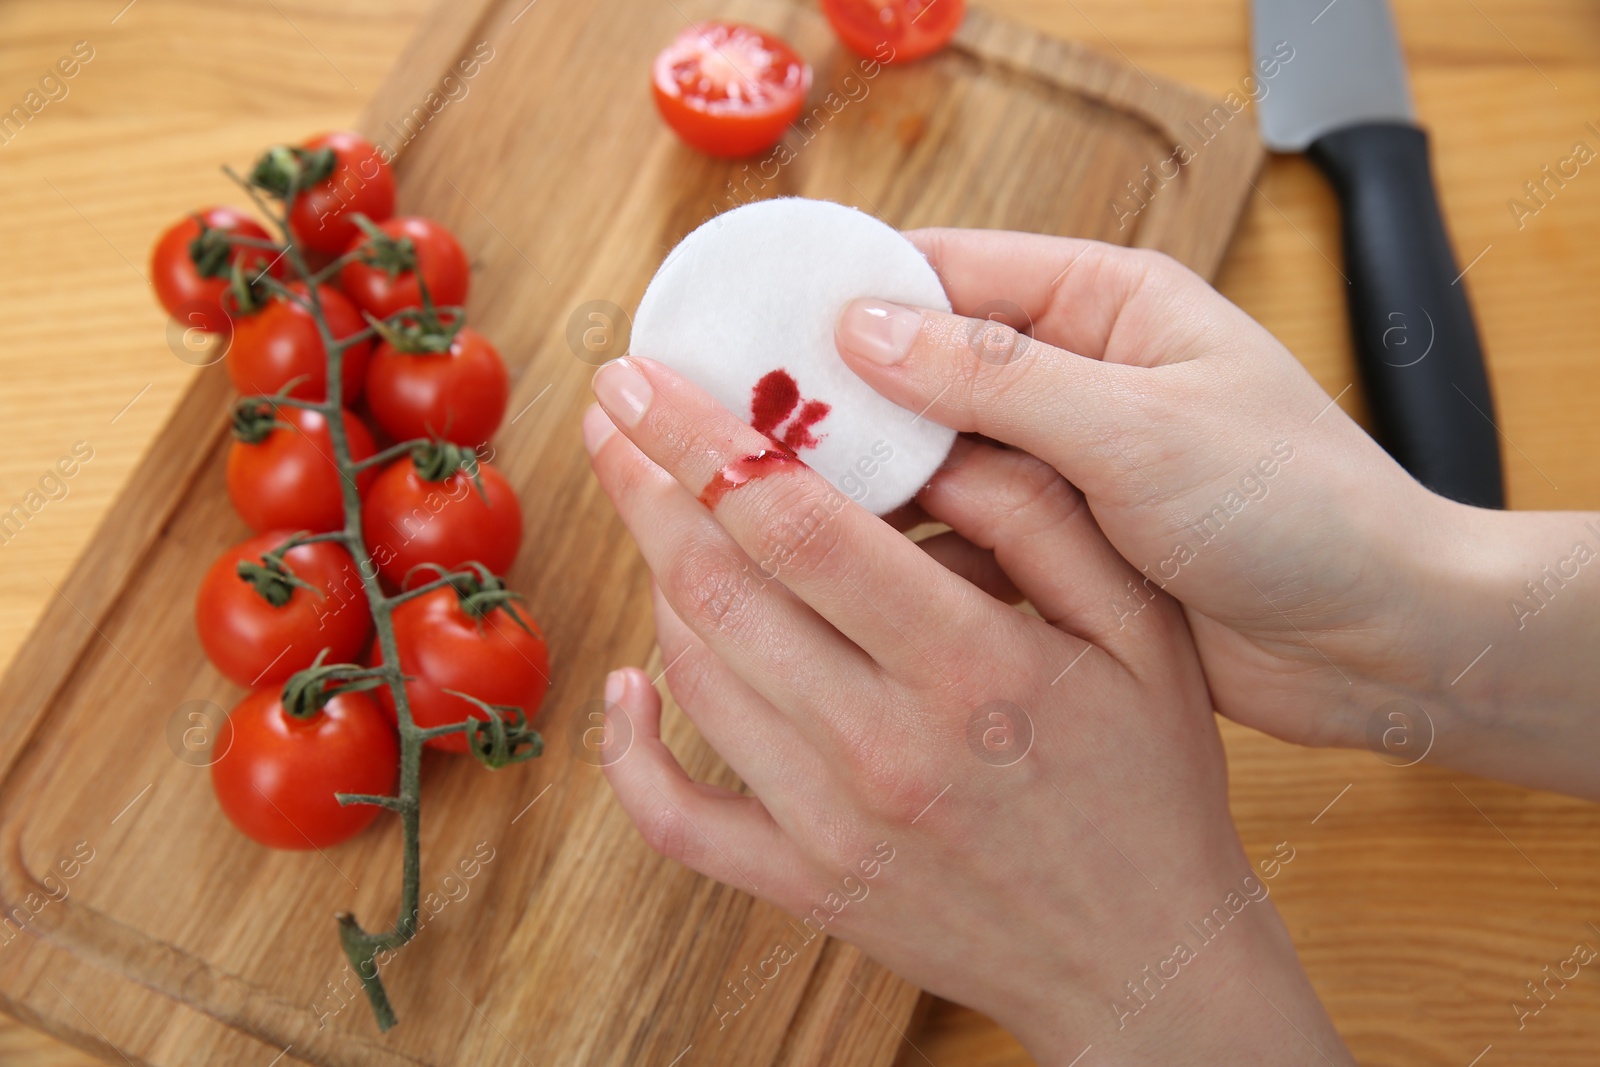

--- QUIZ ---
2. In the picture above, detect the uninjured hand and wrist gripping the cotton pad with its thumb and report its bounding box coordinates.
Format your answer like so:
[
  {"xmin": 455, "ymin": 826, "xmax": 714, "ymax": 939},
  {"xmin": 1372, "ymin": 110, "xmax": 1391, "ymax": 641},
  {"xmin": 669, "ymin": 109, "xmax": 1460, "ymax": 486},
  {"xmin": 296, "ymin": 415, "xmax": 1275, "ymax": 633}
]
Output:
[{"xmin": 837, "ymin": 230, "xmax": 1600, "ymax": 797}]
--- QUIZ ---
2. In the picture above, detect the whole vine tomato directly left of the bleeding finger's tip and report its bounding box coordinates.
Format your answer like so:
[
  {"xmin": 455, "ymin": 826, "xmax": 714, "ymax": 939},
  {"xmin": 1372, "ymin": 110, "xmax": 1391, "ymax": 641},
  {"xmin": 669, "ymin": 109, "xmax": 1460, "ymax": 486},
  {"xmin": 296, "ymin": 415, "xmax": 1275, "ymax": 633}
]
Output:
[{"xmin": 366, "ymin": 326, "xmax": 510, "ymax": 446}]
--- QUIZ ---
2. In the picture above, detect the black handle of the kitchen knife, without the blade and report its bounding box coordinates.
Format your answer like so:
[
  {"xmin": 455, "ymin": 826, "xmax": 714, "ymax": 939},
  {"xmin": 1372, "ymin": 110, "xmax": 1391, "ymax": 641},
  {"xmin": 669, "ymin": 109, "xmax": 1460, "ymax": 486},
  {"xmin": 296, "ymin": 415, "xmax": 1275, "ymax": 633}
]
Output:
[{"xmin": 1307, "ymin": 122, "xmax": 1506, "ymax": 507}]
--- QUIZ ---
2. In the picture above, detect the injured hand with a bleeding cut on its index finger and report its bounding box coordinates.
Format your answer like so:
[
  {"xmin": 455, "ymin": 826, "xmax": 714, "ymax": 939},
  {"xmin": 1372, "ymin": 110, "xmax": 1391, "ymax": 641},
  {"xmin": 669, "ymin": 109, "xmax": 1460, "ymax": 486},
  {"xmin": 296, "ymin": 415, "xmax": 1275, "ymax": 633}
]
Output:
[{"xmin": 584, "ymin": 358, "xmax": 1352, "ymax": 1065}]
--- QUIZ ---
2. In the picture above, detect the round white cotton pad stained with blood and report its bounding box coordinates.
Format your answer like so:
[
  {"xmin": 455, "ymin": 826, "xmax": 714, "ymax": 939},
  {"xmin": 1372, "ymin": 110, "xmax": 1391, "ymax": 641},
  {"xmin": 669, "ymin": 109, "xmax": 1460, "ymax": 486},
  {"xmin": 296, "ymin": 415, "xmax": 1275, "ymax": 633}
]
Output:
[{"xmin": 629, "ymin": 197, "xmax": 955, "ymax": 515}]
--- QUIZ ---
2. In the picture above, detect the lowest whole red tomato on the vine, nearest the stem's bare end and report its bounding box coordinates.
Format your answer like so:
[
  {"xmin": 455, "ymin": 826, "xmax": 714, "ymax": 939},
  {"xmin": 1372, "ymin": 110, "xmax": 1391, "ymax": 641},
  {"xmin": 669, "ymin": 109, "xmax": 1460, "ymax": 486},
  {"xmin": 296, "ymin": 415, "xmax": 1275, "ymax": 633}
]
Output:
[{"xmin": 211, "ymin": 689, "xmax": 400, "ymax": 849}]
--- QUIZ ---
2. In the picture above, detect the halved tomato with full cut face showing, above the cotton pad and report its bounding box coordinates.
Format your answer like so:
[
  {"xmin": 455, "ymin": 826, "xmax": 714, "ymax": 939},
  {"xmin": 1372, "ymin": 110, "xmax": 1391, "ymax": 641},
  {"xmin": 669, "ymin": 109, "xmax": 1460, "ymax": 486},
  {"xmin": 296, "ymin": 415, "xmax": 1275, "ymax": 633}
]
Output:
[{"xmin": 651, "ymin": 22, "xmax": 811, "ymax": 157}]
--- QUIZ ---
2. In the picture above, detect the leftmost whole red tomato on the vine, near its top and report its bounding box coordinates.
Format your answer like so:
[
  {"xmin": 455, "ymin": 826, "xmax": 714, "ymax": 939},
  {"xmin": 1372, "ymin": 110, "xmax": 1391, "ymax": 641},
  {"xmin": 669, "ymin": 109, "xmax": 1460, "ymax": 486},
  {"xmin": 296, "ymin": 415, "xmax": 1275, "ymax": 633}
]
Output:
[{"xmin": 150, "ymin": 208, "xmax": 283, "ymax": 333}]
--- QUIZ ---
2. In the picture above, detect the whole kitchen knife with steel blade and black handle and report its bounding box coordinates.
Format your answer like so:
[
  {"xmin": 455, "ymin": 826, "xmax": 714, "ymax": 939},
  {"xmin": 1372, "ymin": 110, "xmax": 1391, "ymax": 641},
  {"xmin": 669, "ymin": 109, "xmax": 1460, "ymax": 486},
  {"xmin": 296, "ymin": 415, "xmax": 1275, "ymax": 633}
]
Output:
[{"xmin": 1251, "ymin": 0, "xmax": 1504, "ymax": 507}]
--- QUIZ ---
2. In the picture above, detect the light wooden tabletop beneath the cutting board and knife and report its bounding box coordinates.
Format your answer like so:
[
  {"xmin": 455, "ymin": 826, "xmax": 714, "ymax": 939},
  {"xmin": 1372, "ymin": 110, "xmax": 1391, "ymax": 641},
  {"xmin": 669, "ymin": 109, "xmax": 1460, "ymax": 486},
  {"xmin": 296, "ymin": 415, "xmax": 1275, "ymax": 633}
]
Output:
[{"xmin": 0, "ymin": 0, "xmax": 1600, "ymax": 1067}]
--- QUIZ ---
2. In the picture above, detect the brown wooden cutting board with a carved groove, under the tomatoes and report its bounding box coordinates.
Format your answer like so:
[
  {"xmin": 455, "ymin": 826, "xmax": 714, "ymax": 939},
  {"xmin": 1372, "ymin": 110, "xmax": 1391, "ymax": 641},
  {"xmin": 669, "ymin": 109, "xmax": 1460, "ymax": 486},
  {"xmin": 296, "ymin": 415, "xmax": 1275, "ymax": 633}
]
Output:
[{"xmin": 0, "ymin": 0, "xmax": 1261, "ymax": 1067}]
